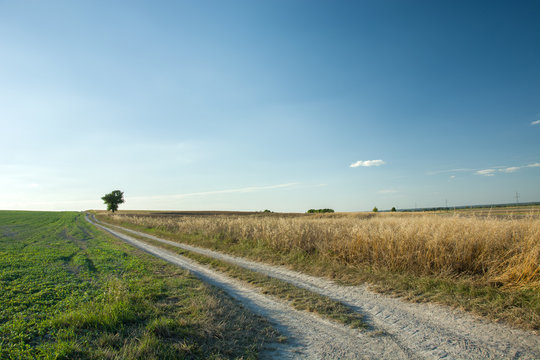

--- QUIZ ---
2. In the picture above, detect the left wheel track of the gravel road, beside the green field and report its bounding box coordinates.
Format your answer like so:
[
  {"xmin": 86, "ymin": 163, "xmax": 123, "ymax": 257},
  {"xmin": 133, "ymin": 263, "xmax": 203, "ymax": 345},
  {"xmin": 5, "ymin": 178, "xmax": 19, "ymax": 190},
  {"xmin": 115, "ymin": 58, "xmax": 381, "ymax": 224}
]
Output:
[{"xmin": 86, "ymin": 216, "xmax": 417, "ymax": 359}]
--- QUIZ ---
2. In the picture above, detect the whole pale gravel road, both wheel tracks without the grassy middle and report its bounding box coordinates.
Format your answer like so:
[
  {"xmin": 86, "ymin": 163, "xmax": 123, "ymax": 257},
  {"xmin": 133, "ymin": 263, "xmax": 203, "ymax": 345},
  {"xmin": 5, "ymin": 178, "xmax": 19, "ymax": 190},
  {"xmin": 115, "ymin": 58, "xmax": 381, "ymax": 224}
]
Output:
[{"xmin": 86, "ymin": 215, "xmax": 540, "ymax": 359}]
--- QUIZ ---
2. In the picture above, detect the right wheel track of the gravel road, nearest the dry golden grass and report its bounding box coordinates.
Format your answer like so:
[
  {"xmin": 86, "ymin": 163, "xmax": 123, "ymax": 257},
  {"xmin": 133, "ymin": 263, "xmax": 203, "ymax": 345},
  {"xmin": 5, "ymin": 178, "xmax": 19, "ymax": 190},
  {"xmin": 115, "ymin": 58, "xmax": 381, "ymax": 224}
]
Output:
[{"xmin": 97, "ymin": 217, "xmax": 540, "ymax": 359}]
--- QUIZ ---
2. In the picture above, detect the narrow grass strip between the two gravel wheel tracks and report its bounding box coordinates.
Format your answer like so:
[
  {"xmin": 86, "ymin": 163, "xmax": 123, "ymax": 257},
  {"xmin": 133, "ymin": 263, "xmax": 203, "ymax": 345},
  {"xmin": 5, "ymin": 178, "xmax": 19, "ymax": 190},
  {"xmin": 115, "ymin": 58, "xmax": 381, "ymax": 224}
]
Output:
[{"xmin": 100, "ymin": 223, "xmax": 367, "ymax": 329}]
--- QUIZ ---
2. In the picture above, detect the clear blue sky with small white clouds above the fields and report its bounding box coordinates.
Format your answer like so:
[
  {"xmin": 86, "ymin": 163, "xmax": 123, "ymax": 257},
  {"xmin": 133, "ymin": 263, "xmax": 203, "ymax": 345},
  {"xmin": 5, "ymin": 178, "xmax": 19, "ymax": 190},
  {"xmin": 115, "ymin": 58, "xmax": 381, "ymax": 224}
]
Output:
[{"xmin": 0, "ymin": 0, "xmax": 540, "ymax": 211}]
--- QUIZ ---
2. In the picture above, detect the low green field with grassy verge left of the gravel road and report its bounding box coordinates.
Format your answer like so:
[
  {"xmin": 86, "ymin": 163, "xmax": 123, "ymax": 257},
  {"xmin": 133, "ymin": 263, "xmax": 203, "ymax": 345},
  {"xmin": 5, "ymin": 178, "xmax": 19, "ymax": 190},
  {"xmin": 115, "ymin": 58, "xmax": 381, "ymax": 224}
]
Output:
[{"xmin": 0, "ymin": 211, "xmax": 278, "ymax": 359}]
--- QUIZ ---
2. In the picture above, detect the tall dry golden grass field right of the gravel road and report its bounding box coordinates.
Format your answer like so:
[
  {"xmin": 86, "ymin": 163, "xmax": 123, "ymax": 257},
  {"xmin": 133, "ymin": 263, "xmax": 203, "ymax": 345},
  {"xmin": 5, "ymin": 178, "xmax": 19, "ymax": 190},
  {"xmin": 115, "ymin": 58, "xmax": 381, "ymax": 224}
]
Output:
[{"xmin": 107, "ymin": 213, "xmax": 540, "ymax": 288}]
